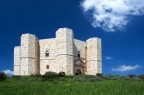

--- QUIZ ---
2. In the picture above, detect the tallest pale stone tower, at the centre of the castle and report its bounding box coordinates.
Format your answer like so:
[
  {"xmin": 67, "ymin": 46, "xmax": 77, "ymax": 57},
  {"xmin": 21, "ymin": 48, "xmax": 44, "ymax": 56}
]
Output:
[{"xmin": 56, "ymin": 28, "xmax": 74, "ymax": 75}]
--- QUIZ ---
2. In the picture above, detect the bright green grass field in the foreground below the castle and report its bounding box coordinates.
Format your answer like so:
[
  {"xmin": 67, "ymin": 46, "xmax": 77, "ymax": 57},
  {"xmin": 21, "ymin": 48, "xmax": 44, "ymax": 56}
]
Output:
[{"xmin": 0, "ymin": 80, "xmax": 144, "ymax": 95}]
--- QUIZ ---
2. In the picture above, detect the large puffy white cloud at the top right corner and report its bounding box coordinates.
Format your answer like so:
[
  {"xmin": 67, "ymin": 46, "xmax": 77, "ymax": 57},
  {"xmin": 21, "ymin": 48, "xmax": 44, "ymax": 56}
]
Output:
[{"xmin": 80, "ymin": 0, "xmax": 144, "ymax": 32}]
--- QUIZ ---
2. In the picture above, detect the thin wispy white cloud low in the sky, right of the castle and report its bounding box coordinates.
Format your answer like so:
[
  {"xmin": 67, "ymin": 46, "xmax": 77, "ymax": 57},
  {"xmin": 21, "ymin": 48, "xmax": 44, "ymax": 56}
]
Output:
[{"xmin": 112, "ymin": 65, "xmax": 140, "ymax": 72}]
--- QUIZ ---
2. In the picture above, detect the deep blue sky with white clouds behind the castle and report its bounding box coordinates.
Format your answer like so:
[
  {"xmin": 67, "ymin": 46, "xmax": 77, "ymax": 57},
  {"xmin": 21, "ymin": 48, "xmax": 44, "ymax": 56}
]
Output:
[{"xmin": 0, "ymin": 0, "xmax": 144, "ymax": 75}]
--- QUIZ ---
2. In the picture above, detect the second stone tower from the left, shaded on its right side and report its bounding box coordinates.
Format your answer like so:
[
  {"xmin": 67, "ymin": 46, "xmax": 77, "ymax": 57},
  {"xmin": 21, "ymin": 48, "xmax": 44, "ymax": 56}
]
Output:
[{"xmin": 20, "ymin": 34, "xmax": 39, "ymax": 75}]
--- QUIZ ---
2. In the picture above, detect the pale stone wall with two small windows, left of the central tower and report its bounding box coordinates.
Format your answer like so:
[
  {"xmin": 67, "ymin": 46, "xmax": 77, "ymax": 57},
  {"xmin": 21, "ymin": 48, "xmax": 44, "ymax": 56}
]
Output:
[{"xmin": 39, "ymin": 38, "xmax": 59, "ymax": 75}]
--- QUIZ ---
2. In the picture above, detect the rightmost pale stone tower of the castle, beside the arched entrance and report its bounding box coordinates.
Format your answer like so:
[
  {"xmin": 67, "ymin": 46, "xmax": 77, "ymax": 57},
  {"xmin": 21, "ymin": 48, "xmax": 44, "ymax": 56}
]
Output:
[{"xmin": 87, "ymin": 38, "xmax": 102, "ymax": 75}]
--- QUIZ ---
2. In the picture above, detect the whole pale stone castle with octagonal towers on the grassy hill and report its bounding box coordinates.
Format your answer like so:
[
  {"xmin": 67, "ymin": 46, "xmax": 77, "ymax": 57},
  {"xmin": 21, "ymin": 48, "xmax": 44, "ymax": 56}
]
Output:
[{"xmin": 14, "ymin": 28, "xmax": 102, "ymax": 76}]
